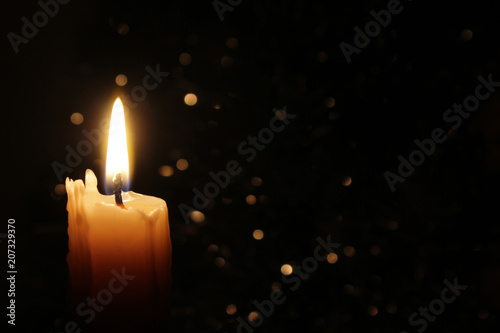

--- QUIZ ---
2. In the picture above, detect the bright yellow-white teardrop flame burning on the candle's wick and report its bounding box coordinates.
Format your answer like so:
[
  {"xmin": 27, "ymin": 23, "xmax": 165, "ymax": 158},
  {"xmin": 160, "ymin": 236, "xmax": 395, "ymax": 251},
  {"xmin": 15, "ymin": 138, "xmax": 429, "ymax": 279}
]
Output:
[{"xmin": 106, "ymin": 98, "xmax": 130, "ymax": 191}]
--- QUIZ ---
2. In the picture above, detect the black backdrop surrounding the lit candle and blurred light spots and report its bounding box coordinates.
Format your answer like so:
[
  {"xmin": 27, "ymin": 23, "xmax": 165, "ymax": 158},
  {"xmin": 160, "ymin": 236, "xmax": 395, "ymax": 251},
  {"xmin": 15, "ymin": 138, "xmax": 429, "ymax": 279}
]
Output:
[{"xmin": 0, "ymin": 0, "xmax": 500, "ymax": 332}]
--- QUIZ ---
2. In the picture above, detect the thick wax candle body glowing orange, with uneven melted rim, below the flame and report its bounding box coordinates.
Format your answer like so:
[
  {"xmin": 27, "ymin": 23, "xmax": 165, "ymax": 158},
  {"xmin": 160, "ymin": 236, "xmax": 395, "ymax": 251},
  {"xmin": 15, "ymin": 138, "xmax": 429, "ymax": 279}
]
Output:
[{"xmin": 66, "ymin": 170, "xmax": 172, "ymax": 332}]
